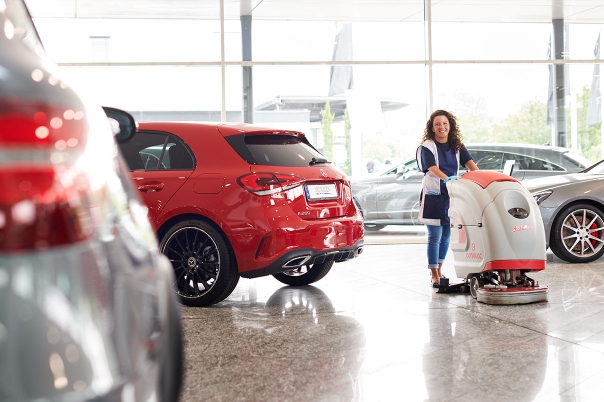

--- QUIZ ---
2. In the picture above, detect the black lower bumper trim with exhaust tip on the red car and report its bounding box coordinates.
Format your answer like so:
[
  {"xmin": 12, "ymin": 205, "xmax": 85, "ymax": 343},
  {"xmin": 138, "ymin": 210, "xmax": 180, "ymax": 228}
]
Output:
[{"xmin": 240, "ymin": 240, "xmax": 364, "ymax": 278}]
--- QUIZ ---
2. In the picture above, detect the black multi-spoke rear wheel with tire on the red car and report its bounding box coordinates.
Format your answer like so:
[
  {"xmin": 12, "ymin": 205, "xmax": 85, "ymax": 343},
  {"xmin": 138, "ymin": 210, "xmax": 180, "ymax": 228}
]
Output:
[{"xmin": 159, "ymin": 219, "xmax": 239, "ymax": 307}]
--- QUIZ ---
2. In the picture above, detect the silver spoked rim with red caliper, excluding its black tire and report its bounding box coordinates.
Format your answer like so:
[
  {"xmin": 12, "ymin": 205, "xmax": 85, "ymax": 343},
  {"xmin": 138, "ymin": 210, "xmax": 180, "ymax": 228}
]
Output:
[{"xmin": 559, "ymin": 208, "xmax": 604, "ymax": 260}]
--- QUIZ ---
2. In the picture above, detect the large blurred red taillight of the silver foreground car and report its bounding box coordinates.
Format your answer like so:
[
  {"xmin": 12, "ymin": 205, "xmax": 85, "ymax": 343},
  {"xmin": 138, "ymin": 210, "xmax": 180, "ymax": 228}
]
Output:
[{"xmin": 0, "ymin": 102, "xmax": 93, "ymax": 252}]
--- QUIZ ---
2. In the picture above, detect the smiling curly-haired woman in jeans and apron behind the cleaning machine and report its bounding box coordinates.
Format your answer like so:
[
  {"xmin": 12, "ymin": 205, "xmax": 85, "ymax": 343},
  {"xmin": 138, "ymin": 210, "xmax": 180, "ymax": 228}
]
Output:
[{"xmin": 417, "ymin": 110, "xmax": 478, "ymax": 287}]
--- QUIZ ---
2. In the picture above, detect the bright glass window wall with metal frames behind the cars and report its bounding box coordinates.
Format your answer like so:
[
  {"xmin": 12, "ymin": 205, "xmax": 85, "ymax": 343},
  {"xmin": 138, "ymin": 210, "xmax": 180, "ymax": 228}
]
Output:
[{"xmin": 27, "ymin": 0, "xmax": 604, "ymax": 175}]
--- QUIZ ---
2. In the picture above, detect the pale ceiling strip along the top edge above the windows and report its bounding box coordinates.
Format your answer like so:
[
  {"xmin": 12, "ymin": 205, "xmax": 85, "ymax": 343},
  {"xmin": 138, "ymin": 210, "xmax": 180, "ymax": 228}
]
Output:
[{"xmin": 25, "ymin": 0, "xmax": 604, "ymax": 24}]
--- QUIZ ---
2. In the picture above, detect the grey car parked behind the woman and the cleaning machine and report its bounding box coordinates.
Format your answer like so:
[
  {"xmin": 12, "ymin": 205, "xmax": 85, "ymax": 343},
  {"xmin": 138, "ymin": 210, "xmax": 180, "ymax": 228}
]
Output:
[{"xmin": 351, "ymin": 144, "xmax": 592, "ymax": 230}]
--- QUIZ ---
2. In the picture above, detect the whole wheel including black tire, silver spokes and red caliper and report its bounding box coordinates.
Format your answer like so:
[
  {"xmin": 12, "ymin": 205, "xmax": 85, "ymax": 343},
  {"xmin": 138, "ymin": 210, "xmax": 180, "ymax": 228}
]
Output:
[{"xmin": 550, "ymin": 204, "xmax": 604, "ymax": 263}]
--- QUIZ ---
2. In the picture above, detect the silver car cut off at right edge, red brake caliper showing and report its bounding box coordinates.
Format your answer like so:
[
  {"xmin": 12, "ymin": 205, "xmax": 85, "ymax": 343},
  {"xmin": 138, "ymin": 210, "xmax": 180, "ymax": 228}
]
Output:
[{"xmin": 523, "ymin": 161, "xmax": 604, "ymax": 263}]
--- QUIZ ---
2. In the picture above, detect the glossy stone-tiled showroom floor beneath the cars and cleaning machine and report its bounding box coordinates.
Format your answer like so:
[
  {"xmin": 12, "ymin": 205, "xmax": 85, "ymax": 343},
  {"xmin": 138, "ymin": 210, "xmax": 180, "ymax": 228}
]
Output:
[{"xmin": 181, "ymin": 228, "xmax": 604, "ymax": 402}]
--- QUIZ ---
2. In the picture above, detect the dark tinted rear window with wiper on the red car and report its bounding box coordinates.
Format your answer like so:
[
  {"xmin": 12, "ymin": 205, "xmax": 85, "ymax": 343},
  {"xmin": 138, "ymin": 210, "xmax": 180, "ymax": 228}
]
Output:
[{"xmin": 226, "ymin": 135, "xmax": 330, "ymax": 166}]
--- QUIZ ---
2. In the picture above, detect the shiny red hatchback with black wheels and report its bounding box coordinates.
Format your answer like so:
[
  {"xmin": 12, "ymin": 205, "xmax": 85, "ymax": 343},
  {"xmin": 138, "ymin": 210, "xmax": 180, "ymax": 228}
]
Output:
[{"xmin": 120, "ymin": 122, "xmax": 364, "ymax": 306}]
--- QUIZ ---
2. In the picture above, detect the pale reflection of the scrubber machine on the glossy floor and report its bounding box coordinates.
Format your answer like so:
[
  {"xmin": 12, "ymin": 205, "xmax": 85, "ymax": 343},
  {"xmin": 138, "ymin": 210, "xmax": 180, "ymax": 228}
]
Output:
[{"xmin": 422, "ymin": 307, "xmax": 548, "ymax": 402}]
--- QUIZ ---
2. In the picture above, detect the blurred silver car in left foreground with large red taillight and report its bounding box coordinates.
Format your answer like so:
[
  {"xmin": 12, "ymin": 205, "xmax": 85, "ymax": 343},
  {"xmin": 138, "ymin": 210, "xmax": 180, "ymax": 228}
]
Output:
[{"xmin": 0, "ymin": 0, "xmax": 182, "ymax": 402}]
